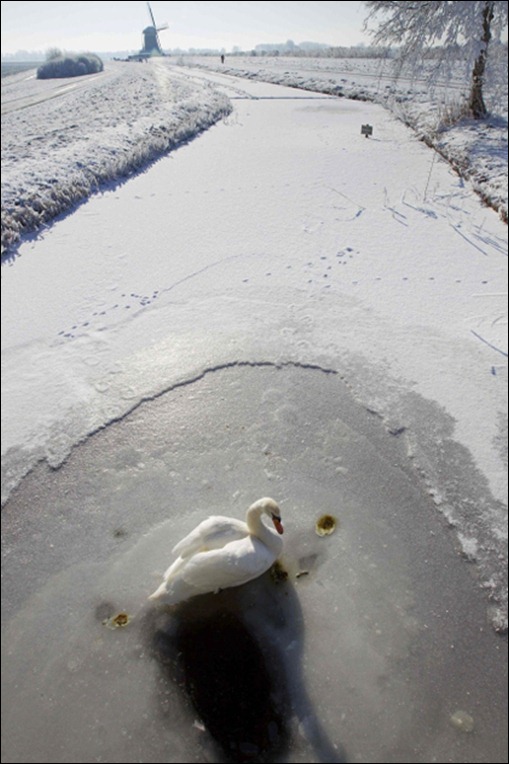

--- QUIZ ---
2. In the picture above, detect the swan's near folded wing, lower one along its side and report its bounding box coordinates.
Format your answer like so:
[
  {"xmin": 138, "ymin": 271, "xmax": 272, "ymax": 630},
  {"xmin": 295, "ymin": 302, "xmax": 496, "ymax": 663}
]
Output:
[{"xmin": 177, "ymin": 536, "xmax": 275, "ymax": 594}]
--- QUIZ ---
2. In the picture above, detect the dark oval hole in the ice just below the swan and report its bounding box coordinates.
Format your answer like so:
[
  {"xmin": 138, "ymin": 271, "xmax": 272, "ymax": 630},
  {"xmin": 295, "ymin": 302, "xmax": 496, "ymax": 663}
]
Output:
[{"xmin": 151, "ymin": 603, "xmax": 291, "ymax": 762}]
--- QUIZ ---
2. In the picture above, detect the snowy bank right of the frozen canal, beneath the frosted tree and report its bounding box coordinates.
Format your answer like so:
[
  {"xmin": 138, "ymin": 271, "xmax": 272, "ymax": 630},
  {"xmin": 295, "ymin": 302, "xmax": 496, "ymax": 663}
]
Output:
[{"xmin": 179, "ymin": 55, "xmax": 507, "ymax": 222}]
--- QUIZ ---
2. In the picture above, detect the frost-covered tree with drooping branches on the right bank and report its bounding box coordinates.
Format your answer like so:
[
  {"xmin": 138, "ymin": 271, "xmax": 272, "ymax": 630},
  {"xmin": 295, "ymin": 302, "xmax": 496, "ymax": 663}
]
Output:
[{"xmin": 364, "ymin": 0, "xmax": 508, "ymax": 119}]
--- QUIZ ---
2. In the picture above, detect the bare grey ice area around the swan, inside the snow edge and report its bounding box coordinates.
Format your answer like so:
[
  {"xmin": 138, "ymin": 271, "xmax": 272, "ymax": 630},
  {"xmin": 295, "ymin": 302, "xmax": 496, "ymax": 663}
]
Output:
[{"xmin": 3, "ymin": 367, "xmax": 506, "ymax": 762}]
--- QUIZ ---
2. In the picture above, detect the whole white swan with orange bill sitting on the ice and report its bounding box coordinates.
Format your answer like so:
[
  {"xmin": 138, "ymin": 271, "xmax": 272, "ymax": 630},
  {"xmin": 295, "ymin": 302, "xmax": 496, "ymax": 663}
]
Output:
[{"xmin": 149, "ymin": 498, "xmax": 283, "ymax": 605}]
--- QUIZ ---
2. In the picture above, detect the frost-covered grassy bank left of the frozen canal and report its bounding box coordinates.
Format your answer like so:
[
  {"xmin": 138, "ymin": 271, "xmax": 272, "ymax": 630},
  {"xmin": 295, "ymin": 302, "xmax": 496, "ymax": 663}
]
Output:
[{"xmin": 2, "ymin": 59, "xmax": 231, "ymax": 252}]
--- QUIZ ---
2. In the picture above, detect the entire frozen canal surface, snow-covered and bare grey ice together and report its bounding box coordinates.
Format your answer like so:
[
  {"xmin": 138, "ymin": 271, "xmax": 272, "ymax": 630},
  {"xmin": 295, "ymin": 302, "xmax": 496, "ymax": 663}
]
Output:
[{"xmin": 2, "ymin": 63, "xmax": 507, "ymax": 764}]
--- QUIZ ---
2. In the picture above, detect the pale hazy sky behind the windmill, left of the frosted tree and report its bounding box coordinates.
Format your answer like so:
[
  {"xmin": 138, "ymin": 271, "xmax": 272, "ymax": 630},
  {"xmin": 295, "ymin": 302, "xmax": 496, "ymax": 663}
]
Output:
[{"xmin": 1, "ymin": 0, "xmax": 369, "ymax": 55}]
